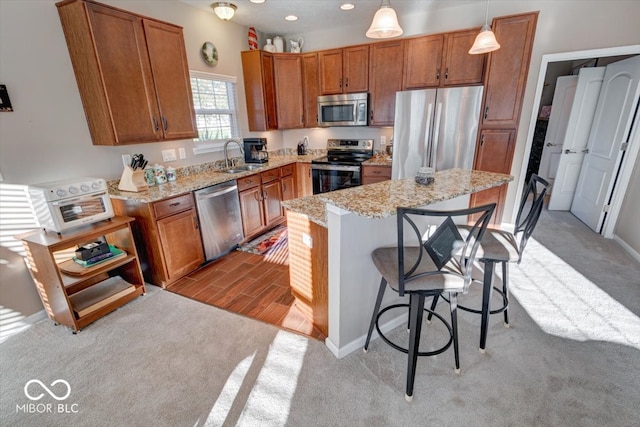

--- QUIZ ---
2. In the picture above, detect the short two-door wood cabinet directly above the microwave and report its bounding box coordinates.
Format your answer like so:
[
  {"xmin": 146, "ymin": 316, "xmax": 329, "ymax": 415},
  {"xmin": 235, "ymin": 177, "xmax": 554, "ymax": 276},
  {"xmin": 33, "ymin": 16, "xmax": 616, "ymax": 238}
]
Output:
[{"xmin": 318, "ymin": 45, "xmax": 369, "ymax": 95}]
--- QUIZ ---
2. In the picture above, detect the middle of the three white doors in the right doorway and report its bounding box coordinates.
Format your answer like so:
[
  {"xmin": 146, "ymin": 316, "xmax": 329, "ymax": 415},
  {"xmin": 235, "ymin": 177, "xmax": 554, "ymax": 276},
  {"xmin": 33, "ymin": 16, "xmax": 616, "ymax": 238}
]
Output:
[{"xmin": 549, "ymin": 67, "xmax": 605, "ymax": 211}]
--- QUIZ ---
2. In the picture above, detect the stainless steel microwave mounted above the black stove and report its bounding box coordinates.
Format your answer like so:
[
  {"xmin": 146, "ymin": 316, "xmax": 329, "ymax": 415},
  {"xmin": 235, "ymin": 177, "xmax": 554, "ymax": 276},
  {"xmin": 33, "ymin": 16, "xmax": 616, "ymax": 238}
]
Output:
[{"xmin": 318, "ymin": 92, "xmax": 369, "ymax": 127}]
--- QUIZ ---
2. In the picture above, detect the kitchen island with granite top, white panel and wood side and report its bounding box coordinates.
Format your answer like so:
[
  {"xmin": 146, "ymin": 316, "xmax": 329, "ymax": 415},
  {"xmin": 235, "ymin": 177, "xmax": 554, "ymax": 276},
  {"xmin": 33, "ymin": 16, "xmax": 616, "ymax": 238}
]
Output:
[{"xmin": 283, "ymin": 169, "xmax": 513, "ymax": 358}]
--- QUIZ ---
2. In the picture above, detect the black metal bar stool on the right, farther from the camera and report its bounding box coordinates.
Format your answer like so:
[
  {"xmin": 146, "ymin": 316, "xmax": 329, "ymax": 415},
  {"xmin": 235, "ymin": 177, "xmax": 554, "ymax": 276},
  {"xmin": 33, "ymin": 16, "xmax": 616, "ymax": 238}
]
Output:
[{"xmin": 429, "ymin": 174, "xmax": 549, "ymax": 353}]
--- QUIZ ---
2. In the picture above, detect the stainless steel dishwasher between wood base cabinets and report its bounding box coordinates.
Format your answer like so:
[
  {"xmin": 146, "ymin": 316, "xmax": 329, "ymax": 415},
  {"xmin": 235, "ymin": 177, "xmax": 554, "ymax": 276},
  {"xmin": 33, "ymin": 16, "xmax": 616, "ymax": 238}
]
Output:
[{"xmin": 194, "ymin": 181, "xmax": 244, "ymax": 261}]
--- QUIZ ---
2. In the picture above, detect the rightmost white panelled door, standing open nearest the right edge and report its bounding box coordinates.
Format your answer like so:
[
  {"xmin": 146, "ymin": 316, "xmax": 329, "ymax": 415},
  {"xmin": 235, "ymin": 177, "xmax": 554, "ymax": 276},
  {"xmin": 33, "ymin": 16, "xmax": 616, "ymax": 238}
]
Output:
[{"xmin": 571, "ymin": 56, "xmax": 640, "ymax": 233}]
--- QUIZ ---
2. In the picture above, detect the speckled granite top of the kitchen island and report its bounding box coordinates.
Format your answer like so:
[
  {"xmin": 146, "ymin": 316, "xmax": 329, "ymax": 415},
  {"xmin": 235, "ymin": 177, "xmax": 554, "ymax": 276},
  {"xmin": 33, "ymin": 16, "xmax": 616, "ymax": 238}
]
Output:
[{"xmin": 282, "ymin": 169, "xmax": 513, "ymax": 227}]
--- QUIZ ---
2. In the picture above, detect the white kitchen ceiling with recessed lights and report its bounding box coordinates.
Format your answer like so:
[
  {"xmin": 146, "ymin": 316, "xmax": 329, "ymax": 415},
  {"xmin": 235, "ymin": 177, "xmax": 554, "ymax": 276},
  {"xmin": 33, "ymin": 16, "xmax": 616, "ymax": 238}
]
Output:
[{"xmin": 179, "ymin": 0, "xmax": 485, "ymax": 36}]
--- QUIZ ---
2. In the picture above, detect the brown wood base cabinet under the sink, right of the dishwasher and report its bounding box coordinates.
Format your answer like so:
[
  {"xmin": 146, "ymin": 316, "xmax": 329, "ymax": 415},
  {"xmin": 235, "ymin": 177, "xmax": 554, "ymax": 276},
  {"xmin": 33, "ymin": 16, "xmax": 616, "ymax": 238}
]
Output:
[{"xmin": 237, "ymin": 168, "xmax": 284, "ymax": 241}]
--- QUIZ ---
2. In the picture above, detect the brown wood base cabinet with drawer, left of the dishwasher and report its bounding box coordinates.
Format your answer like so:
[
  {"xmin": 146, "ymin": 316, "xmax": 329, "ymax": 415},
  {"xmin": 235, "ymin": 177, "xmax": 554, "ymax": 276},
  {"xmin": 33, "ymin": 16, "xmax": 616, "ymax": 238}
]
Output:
[{"xmin": 112, "ymin": 193, "xmax": 204, "ymax": 288}]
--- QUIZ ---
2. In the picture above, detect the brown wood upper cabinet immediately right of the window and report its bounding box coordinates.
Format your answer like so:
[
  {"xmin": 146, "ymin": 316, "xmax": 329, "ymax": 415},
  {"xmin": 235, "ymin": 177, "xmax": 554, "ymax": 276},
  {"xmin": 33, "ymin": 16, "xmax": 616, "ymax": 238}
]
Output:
[{"xmin": 240, "ymin": 50, "xmax": 278, "ymax": 131}]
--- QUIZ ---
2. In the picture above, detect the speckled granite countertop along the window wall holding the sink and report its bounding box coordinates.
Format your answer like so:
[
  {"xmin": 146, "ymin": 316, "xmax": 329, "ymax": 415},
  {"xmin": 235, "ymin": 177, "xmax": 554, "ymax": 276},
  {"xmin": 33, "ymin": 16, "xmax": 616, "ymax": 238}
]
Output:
[{"xmin": 108, "ymin": 154, "xmax": 319, "ymax": 203}]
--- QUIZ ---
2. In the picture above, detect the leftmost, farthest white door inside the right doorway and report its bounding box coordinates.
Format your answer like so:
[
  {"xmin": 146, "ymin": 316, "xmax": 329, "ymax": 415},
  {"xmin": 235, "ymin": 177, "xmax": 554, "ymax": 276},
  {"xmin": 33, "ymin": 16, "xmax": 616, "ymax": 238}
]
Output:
[{"xmin": 538, "ymin": 76, "xmax": 578, "ymax": 192}]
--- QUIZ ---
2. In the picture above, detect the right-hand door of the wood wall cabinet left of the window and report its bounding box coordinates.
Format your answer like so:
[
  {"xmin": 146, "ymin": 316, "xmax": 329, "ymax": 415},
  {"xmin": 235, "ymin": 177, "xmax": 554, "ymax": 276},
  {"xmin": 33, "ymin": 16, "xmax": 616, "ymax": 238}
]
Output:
[{"xmin": 143, "ymin": 19, "xmax": 198, "ymax": 139}]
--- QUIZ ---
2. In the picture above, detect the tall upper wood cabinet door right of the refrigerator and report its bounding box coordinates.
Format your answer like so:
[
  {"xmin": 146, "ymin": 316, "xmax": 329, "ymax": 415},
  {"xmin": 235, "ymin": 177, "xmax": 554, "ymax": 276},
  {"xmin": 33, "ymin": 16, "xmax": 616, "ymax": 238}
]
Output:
[{"xmin": 482, "ymin": 13, "xmax": 538, "ymax": 128}]
